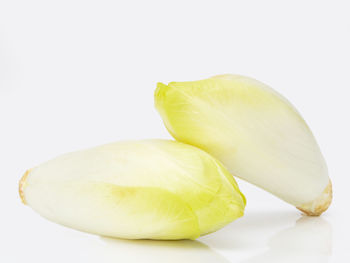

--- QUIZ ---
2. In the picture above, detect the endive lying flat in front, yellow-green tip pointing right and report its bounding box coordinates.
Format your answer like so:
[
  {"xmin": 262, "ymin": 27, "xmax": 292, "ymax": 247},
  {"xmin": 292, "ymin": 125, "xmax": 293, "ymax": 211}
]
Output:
[{"xmin": 19, "ymin": 140, "xmax": 245, "ymax": 239}]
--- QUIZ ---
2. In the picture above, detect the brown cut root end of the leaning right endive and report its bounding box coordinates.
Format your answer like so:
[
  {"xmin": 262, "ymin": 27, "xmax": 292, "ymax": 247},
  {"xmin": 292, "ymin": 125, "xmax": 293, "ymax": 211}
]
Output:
[{"xmin": 297, "ymin": 180, "xmax": 332, "ymax": 216}]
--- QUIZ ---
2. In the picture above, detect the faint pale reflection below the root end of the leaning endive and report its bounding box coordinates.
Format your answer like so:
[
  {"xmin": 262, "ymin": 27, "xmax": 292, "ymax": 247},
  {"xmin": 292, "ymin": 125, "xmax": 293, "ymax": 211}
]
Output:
[{"xmin": 242, "ymin": 216, "xmax": 332, "ymax": 263}]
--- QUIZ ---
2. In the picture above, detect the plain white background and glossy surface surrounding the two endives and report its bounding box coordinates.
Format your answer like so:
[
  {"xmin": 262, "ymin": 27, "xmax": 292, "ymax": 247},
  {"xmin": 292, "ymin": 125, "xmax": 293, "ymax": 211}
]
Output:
[{"xmin": 0, "ymin": 0, "xmax": 350, "ymax": 263}]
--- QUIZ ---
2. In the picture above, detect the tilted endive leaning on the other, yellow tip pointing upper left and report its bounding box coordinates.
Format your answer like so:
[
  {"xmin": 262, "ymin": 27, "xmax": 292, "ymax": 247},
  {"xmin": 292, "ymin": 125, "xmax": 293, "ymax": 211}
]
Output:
[{"xmin": 155, "ymin": 75, "xmax": 332, "ymax": 215}]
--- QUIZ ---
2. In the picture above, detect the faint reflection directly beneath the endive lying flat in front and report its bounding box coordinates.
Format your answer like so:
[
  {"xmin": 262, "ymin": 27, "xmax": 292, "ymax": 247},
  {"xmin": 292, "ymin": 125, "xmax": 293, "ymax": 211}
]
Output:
[{"xmin": 101, "ymin": 237, "xmax": 229, "ymax": 263}]
